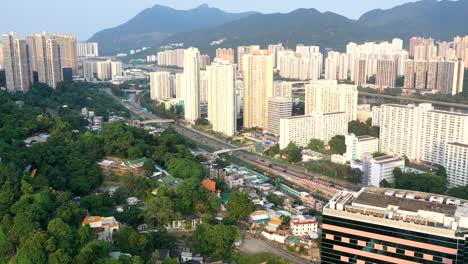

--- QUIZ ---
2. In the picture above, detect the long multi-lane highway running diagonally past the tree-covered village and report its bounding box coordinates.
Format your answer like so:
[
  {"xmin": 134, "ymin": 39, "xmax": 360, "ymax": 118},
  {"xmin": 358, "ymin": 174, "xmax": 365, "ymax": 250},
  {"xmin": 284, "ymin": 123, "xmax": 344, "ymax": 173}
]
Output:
[{"xmin": 105, "ymin": 89, "xmax": 360, "ymax": 200}]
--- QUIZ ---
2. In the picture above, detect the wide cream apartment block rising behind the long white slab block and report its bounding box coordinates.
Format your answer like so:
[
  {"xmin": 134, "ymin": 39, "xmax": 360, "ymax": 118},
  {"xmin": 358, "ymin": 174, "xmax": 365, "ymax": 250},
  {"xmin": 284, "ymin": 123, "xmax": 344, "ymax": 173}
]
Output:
[{"xmin": 305, "ymin": 80, "xmax": 358, "ymax": 122}]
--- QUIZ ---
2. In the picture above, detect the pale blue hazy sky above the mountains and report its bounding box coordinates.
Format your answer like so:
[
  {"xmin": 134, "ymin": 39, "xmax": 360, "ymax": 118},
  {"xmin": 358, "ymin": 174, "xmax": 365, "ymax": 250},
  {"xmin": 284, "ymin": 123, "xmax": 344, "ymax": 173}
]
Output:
[{"xmin": 0, "ymin": 0, "xmax": 410, "ymax": 40}]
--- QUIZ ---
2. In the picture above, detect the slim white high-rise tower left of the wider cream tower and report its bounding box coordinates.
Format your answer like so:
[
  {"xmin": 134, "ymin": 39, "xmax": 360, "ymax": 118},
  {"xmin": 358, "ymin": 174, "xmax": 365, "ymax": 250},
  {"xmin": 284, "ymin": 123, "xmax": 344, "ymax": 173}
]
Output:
[{"xmin": 183, "ymin": 48, "xmax": 200, "ymax": 124}]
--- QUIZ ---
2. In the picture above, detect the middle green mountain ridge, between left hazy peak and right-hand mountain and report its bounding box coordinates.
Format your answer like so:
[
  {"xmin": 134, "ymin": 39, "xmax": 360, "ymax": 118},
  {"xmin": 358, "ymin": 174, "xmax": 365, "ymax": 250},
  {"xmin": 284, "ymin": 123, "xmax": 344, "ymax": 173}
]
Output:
[{"xmin": 163, "ymin": 9, "xmax": 374, "ymax": 54}]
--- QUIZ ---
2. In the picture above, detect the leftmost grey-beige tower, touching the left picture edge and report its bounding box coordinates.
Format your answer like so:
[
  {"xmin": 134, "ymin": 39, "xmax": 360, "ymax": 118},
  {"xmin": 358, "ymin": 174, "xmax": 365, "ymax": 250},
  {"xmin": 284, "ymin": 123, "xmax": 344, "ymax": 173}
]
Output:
[{"xmin": 2, "ymin": 32, "xmax": 31, "ymax": 92}]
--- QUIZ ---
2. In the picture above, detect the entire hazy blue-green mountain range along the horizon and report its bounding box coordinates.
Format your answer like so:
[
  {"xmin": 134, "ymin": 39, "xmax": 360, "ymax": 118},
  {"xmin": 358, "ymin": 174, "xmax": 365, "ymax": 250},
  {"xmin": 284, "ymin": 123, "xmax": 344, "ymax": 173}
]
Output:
[{"xmin": 90, "ymin": 0, "xmax": 468, "ymax": 54}]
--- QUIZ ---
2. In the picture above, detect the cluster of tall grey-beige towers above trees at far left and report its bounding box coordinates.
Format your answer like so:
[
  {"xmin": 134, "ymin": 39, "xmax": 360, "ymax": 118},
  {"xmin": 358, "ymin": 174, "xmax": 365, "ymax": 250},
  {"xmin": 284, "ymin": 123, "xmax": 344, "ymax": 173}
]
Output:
[{"xmin": 2, "ymin": 32, "xmax": 78, "ymax": 92}]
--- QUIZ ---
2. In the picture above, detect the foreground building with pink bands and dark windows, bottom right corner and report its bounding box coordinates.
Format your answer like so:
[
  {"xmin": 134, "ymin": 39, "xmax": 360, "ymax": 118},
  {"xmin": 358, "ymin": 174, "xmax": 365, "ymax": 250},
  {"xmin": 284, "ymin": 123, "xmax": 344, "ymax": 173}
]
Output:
[{"xmin": 321, "ymin": 188, "xmax": 468, "ymax": 264}]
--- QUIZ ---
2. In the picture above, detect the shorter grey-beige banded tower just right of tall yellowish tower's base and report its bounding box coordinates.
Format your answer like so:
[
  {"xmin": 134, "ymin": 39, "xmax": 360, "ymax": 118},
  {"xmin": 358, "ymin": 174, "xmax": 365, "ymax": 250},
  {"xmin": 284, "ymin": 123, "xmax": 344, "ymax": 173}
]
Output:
[{"xmin": 267, "ymin": 96, "xmax": 292, "ymax": 136}]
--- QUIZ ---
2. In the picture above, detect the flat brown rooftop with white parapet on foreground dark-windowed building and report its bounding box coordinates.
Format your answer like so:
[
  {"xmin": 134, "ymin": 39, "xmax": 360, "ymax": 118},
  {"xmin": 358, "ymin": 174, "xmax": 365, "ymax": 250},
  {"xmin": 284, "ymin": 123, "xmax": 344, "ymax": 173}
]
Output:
[{"xmin": 324, "ymin": 187, "xmax": 468, "ymax": 232}]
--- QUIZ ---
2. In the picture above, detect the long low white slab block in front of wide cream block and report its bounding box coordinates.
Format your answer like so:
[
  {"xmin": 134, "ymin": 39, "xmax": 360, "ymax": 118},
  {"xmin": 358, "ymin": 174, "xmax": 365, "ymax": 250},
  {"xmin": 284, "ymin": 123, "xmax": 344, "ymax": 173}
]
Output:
[{"xmin": 279, "ymin": 112, "xmax": 348, "ymax": 149}]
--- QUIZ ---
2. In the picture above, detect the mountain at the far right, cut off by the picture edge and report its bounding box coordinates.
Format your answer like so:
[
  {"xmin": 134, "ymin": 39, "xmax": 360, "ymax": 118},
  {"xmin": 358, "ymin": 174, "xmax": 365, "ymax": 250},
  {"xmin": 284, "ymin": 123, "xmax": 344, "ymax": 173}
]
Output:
[{"xmin": 358, "ymin": 0, "xmax": 468, "ymax": 40}]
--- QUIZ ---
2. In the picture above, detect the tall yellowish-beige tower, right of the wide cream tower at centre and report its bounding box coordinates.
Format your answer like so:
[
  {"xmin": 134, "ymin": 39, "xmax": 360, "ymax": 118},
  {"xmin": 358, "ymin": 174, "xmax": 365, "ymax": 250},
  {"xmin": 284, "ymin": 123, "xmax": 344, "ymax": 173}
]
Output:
[{"xmin": 242, "ymin": 50, "xmax": 273, "ymax": 128}]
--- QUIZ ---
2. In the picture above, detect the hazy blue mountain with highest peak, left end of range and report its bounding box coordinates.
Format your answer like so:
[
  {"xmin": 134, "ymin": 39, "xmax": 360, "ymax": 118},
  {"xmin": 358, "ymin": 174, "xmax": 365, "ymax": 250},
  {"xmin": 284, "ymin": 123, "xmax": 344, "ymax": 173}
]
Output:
[{"xmin": 89, "ymin": 4, "xmax": 255, "ymax": 55}]
